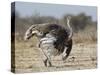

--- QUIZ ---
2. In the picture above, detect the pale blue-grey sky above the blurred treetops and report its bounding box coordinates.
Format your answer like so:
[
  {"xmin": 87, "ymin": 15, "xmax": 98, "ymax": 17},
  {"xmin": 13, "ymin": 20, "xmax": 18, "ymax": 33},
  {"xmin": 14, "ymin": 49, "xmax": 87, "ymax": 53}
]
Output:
[{"xmin": 15, "ymin": 2, "xmax": 97, "ymax": 21}]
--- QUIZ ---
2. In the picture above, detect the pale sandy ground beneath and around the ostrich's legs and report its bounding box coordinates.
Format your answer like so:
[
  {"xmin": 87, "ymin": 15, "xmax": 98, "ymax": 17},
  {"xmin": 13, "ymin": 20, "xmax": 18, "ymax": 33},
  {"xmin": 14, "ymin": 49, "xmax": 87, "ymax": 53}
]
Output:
[{"xmin": 12, "ymin": 42, "xmax": 97, "ymax": 73}]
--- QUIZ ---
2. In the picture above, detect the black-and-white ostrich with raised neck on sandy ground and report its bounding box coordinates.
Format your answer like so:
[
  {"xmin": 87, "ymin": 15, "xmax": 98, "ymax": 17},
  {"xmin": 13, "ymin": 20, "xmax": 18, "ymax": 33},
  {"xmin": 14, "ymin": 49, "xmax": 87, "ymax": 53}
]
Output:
[{"xmin": 24, "ymin": 17, "xmax": 73, "ymax": 67}]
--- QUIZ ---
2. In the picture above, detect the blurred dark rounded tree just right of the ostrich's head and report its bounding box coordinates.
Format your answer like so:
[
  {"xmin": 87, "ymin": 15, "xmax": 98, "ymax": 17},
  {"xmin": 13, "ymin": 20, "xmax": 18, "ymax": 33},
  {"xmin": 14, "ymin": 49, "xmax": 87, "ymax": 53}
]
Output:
[{"xmin": 71, "ymin": 13, "xmax": 92, "ymax": 32}]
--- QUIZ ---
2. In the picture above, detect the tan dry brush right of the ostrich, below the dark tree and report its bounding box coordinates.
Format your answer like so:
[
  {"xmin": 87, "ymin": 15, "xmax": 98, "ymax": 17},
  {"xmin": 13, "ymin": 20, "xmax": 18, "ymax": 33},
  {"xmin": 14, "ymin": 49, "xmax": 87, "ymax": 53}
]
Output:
[{"xmin": 73, "ymin": 26, "xmax": 97, "ymax": 43}]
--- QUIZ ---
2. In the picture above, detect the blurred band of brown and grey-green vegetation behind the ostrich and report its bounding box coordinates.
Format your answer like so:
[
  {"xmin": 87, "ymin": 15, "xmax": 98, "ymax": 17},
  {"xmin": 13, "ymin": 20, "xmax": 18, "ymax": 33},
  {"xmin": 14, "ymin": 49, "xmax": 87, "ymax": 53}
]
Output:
[{"xmin": 12, "ymin": 12, "xmax": 97, "ymax": 43}]
